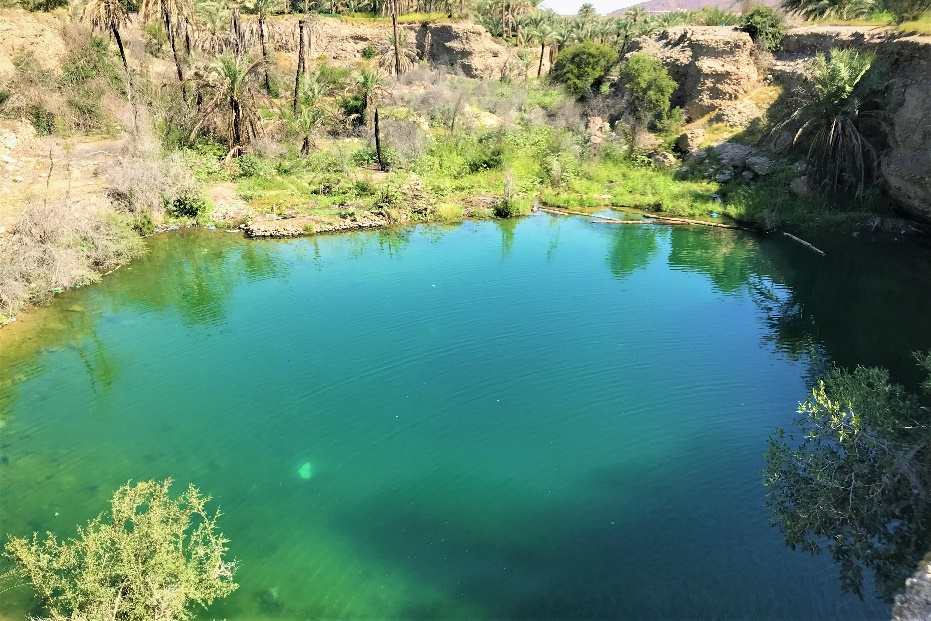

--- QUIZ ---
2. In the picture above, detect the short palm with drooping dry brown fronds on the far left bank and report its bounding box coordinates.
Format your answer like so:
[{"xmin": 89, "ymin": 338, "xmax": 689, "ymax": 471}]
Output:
[{"xmin": 190, "ymin": 52, "xmax": 262, "ymax": 159}]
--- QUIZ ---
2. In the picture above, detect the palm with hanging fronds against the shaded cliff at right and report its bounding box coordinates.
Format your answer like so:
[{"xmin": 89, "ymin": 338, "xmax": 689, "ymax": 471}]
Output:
[{"xmin": 775, "ymin": 49, "xmax": 892, "ymax": 196}]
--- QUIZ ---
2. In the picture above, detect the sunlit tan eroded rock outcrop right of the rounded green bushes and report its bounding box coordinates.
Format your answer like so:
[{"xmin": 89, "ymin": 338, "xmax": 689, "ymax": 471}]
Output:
[{"xmin": 634, "ymin": 26, "xmax": 759, "ymax": 118}]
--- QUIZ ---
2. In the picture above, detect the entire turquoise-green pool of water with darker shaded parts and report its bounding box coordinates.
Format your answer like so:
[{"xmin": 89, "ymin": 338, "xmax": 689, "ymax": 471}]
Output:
[{"xmin": 0, "ymin": 215, "xmax": 931, "ymax": 619}]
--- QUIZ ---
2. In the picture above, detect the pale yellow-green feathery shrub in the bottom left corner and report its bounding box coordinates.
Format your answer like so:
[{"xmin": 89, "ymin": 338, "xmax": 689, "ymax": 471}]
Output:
[{"xmin": 5, "ymin": 479, "xmax": 238, "ymax": 621}]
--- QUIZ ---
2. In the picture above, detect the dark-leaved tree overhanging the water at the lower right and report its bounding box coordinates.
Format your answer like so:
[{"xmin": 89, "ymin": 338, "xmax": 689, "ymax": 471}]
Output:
[{"xmin": 766, "ymin": 354, "xmax": 931, "ymax": 602}]
